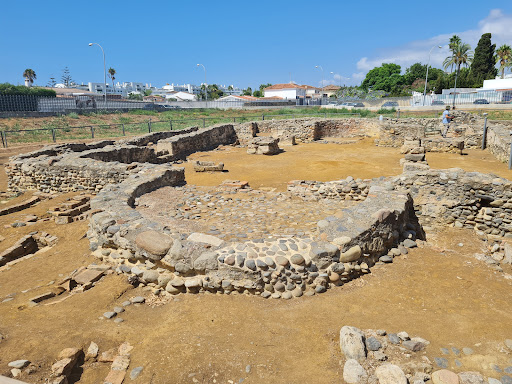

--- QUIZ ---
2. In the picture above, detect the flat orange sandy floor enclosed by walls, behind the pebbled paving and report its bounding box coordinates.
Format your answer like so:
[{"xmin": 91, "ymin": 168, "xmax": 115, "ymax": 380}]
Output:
[{"xmin": 184, "ymin": 138, "xmax": 512, "ymax": 191}]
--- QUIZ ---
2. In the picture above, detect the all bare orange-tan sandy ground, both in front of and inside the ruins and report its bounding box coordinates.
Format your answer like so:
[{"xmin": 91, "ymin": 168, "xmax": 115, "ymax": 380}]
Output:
[{"xmin": 0, "ymin": 142, "xmax": 512, "ymax": 384}]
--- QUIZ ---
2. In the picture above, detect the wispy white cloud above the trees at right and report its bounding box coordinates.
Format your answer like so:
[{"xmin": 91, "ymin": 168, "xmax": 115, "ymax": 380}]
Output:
[{"xmin": 357, "ymin": 9, "xmax": 512, "ymax": 73}]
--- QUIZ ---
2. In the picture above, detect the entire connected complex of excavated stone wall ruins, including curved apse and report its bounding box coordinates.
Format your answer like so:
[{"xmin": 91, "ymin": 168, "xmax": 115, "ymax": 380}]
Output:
[{"xmin": 6, "ymin": 112, "xmax": 512, "ymax": 299}]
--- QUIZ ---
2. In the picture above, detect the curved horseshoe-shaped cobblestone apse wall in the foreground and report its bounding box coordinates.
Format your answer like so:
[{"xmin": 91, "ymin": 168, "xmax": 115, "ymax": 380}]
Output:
[{"xmin": 87, "ymin": 165, "xmax": 422, "ymax": 299}]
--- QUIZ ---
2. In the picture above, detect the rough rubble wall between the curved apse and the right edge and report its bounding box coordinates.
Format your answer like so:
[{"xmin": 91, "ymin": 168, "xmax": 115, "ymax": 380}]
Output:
[{"xmin": 390, "ymin": 168, "xmax": 512, "ymax": 239}]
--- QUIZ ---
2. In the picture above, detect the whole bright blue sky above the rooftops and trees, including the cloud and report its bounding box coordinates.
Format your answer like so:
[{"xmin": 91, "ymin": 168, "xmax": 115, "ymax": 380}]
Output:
[{"xmin": 0, "ymin": 0, "xmax": 512, "ymax": 89}]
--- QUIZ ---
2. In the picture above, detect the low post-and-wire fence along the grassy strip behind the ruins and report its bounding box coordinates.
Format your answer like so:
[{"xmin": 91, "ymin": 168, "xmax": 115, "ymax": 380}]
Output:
[{"xmin": 0, "ymin": 113, "xmax": 360, "ymax": 148}]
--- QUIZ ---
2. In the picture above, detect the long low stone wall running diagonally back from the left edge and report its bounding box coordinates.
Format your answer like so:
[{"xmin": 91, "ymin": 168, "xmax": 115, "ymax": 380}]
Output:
[{"xmin": 5, "ymin": 125, "xmax": 236, "ymax": 193}]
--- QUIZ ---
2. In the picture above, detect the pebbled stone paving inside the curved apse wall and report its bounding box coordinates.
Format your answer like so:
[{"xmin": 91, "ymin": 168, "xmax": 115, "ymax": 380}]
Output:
[{"xmin": 137, "ymin": 185, "xmax": 355, "ymax": 242}]
